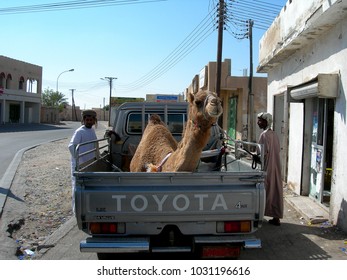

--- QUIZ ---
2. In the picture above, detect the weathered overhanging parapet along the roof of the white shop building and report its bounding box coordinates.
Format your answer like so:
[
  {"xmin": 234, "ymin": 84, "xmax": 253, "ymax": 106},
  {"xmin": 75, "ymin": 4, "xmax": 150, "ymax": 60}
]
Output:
[{"xmin": 258, "ymin": 0, "xmax": 345, "ymax": 73}]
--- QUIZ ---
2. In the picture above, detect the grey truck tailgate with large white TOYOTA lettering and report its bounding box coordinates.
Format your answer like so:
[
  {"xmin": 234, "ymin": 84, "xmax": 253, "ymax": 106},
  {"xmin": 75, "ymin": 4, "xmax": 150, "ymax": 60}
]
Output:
[{"xmin": 75, "ymin": 172, "xmax": 265, "ymax": 227}]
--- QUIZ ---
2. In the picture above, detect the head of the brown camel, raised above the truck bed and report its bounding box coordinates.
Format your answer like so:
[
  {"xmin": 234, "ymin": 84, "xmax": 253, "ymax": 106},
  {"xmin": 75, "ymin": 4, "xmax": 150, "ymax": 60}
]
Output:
[{"xmin": 188, "ymin": 90, "xmax": 223, "ymax": 130}]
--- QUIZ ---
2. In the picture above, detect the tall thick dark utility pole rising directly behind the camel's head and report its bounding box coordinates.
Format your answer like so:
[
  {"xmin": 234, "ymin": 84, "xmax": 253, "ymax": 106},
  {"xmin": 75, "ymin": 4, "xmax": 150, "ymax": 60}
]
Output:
[{"xmin": 216, "ymin": 0, "xmax": 225, "ymax": 96}]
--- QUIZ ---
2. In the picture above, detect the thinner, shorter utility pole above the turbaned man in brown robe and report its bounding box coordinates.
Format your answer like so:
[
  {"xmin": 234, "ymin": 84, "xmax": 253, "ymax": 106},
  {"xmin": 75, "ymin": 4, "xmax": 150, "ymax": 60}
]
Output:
[{"xmin": 248, "ymin": 19, "xmax": 255, "ymax": 142}]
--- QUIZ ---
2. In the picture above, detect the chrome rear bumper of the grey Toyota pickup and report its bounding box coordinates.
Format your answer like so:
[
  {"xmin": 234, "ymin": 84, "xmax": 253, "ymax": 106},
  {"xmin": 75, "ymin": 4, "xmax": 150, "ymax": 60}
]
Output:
[{"xmin": 80, "ymin": 236, "xmax": 261, "ymax": 253}]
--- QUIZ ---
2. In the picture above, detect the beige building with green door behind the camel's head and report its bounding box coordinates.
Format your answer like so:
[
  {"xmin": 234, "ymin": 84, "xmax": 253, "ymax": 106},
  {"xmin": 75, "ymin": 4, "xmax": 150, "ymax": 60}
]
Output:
[{"xmin": 186, "ymin": 59, "xmax": 267, "ymax": 142}]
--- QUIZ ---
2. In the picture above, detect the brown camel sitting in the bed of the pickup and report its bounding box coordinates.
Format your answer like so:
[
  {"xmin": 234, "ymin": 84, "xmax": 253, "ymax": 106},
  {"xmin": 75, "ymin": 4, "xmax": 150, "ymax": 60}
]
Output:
[{"xmin": 130, "ymin": 90, "xmax": 223, "ymax": 172}]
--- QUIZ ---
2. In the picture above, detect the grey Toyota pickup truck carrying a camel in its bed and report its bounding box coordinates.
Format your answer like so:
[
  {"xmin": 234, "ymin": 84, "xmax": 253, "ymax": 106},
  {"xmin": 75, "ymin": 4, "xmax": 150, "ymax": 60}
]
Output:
[{"xmin": 74, "ymin": 102, "xmax": 265, "ymax": 259}]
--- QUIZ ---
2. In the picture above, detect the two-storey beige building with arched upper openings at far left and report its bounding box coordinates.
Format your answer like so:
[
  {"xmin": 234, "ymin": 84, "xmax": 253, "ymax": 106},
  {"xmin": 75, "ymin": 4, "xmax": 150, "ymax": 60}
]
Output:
[{"xmin": 0, "ymin": 55, "xmax": 42, "ymax": 124}]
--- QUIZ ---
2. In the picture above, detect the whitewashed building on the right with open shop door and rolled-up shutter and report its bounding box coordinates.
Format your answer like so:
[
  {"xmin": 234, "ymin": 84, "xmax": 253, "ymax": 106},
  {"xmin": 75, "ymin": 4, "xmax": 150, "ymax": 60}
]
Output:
[{"xmin": 258, "ymin": 0, "xmax": 347, "ymax": 231}]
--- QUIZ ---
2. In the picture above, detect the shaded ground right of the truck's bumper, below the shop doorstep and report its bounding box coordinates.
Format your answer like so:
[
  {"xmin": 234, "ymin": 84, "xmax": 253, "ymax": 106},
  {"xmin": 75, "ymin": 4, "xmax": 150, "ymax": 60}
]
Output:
[{"xmin": 240, "ymin": 222, "xmax": 347, "ymax": 260}]
